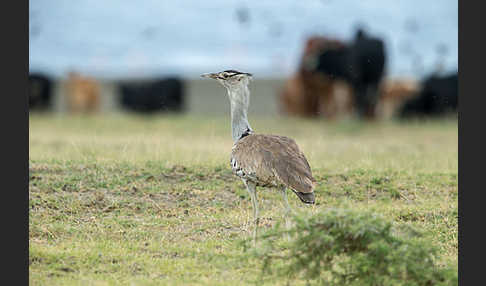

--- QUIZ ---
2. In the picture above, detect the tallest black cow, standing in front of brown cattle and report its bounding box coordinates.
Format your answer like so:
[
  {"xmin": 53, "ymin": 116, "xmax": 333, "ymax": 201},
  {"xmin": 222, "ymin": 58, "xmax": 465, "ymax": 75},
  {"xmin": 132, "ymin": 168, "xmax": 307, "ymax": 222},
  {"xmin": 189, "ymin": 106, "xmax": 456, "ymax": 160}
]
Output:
[{"xmin": 308, "ymin": 30, "xmax": 386, "ymax": 118}]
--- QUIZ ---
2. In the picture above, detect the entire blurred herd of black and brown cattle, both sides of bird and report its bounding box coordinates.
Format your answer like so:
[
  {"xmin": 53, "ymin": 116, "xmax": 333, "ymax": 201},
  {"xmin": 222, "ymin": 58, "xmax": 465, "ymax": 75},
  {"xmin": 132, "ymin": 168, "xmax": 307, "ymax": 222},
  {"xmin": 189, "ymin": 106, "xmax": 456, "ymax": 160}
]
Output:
[{"xmin": 29, "ymin": 30, "xmax": 458, "ymax": 119}]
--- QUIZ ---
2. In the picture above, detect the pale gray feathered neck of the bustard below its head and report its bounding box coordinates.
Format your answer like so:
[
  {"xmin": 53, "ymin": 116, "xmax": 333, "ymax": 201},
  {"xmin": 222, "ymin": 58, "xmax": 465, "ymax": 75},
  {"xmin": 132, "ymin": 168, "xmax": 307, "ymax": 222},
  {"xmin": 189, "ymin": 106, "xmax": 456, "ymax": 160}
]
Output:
[{"xmin": 228, "ymin": 85, "xmax": 253, "ymax": 142}]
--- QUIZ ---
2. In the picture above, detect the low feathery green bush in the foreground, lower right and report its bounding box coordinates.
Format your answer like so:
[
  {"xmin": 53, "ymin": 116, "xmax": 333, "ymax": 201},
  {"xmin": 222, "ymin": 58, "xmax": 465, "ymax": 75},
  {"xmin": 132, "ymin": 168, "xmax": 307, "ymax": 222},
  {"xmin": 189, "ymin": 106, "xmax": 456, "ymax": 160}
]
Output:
[{"xmin": 246, "ymin": 209, "xmax": 458, "ymax": 285}]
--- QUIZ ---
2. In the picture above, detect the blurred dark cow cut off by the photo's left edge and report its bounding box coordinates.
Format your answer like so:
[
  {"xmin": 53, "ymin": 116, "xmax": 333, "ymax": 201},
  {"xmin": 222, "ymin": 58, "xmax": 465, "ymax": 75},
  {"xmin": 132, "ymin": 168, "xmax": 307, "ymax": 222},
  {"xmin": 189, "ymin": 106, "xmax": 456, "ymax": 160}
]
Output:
[{"xmin": 29, "ymin": 73, "xmax": 52, "ymax": 110}]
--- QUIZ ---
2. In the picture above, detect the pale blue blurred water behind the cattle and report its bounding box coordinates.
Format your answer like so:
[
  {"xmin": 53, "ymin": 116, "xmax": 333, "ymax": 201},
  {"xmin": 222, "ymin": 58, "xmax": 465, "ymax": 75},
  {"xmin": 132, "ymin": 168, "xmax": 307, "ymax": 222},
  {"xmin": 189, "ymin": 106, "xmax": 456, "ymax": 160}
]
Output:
[{"xmin": 29, "ymin": 0, "xmax": 458, "ymax": 78}]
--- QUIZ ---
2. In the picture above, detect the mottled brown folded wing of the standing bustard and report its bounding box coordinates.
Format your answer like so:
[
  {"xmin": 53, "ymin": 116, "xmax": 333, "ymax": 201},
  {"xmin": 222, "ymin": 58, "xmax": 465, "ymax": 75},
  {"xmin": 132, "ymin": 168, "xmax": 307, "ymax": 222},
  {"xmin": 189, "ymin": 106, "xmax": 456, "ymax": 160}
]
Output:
[{"xmin": 232, "ymin": 134, "xmax": 315, "ymax": 193}]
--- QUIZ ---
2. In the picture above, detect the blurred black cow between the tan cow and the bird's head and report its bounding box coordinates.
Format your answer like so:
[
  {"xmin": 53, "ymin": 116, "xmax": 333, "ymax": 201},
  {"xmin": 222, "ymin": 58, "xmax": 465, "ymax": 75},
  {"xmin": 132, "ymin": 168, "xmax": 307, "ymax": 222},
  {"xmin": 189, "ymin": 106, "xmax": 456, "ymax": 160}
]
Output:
[{"xmin": 120, "ymin": 78, "xmax": 184, "ymax": 113}]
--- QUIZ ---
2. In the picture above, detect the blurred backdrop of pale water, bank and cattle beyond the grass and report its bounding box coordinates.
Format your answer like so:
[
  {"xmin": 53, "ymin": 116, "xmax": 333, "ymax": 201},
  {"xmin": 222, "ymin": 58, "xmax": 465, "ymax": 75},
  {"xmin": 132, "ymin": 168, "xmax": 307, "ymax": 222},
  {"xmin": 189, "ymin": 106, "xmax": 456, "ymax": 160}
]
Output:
[{"xmin": 29, "ymin": 0, "xmax": 458, "ymax": 120}]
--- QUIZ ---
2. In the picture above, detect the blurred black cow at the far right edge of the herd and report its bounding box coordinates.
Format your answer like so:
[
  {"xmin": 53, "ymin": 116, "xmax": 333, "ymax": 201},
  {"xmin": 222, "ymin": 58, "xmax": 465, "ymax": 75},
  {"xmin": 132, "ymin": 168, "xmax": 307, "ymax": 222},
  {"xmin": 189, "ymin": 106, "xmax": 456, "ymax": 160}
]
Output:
[{"xmin": 399, "ymin": 73, "xmax": 459, "ymax": 118}]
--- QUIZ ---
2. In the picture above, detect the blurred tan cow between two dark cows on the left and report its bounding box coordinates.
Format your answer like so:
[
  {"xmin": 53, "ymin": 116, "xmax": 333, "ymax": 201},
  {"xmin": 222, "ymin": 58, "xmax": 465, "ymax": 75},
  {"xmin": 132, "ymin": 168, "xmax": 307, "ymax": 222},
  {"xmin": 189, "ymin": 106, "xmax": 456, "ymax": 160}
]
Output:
[{"xmin": 66, "ymin": 72, "xmax": 100, "ymax": 113}]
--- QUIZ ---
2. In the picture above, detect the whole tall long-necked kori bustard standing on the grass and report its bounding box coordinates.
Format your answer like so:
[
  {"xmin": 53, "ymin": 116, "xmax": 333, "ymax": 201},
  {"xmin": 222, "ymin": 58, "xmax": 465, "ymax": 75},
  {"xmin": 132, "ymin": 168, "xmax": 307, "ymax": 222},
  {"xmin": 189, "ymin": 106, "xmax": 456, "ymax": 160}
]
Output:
[{"xmin": 201, "ymin": 70, "xmax": 315, "ymax": 243}]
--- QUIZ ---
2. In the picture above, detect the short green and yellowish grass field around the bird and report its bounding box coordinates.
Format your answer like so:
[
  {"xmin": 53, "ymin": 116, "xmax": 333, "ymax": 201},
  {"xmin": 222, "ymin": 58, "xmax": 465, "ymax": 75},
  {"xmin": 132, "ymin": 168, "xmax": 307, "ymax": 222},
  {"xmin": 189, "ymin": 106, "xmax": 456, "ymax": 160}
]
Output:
[{"xmin": 29, "ymin": 114, "xmax": 458, "ymax": 285}]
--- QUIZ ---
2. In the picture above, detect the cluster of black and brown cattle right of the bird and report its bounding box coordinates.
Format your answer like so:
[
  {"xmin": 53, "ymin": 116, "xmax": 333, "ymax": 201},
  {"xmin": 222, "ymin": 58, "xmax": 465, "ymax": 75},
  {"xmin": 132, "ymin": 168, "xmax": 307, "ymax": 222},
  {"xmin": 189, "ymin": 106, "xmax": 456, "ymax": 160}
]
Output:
[{"xmin": 279, "ymin": 30, "xmax": 458, "ymax": 119}]
